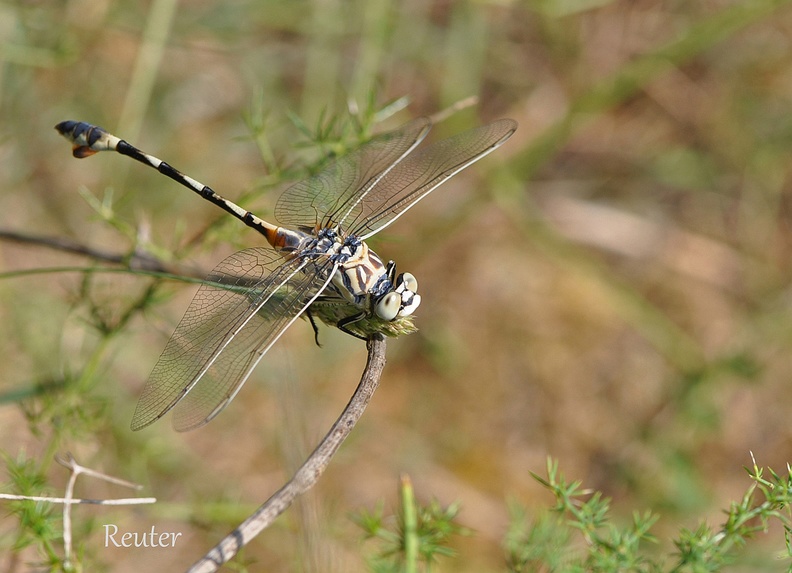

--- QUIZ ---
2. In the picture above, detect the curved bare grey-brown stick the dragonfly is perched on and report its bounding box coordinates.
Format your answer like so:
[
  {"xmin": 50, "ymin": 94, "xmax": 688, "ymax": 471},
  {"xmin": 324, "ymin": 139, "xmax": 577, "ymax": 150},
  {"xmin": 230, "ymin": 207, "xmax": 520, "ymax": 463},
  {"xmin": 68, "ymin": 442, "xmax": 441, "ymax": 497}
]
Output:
[{"xmin": 188, "ymin": 334, "xmax": 385, "ymax": 573}]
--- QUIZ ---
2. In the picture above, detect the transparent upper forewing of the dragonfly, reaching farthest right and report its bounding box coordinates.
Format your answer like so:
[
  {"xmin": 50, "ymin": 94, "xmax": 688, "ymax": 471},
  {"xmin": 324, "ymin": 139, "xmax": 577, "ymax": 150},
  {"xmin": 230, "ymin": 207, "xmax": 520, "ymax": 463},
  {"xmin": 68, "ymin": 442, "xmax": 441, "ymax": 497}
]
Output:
[{"xmin": 338, "ymin": 119, "xmax": 517, "ymax": 240}]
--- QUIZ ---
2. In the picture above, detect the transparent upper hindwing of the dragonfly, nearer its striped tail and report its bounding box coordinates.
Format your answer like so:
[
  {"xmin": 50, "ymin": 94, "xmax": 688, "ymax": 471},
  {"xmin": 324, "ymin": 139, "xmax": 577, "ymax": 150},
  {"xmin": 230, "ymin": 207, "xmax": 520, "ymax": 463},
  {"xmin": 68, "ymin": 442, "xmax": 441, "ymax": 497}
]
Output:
[{"xmin": 275, "ymin": 118, "xmax": 431, "ymax": 227}]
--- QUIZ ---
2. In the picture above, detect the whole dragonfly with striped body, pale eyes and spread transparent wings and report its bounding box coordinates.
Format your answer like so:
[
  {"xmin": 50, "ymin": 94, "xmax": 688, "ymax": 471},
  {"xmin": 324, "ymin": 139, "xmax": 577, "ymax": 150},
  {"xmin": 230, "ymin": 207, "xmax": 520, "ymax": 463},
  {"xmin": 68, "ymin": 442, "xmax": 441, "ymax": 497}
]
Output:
[{"xmin": 55, "ymin": 118, "xmax": 517, "ymax": 431}]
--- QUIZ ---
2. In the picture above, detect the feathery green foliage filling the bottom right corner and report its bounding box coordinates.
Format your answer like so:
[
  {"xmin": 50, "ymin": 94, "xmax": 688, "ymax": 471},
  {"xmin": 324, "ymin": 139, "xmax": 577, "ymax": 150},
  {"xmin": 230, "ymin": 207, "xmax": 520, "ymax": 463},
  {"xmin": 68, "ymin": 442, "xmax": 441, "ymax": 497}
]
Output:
[{"xmin": 505, "ymin": 460, "xmax": 792, "ymax": 573}]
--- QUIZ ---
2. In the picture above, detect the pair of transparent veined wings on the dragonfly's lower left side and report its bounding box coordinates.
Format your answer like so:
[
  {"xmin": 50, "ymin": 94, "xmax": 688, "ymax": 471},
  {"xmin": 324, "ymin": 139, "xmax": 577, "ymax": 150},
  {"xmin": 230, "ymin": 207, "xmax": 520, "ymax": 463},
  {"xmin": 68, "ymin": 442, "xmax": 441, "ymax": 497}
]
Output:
[{"xmin": 132, "ymin": 248, "xmax": 334, "ymax": 431}]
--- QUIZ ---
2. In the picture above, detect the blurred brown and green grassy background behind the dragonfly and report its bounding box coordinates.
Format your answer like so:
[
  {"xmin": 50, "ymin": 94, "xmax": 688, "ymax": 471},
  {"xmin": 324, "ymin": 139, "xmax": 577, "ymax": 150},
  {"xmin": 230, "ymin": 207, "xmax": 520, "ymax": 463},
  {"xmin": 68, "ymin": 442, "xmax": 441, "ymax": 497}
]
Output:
[{"xmin": 0, "ymin": 0, "xmax": 792, "ymax": 571}]
